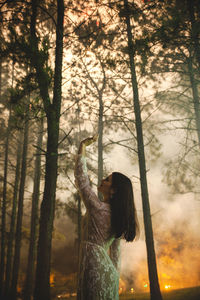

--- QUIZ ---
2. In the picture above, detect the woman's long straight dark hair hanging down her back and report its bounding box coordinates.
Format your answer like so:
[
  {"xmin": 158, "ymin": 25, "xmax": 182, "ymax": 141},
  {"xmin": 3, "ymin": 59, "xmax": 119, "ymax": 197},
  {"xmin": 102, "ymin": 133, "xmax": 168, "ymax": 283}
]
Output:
[{"xmin": 110, "ymin": 172, "xmax": 138, "ymax": 242}]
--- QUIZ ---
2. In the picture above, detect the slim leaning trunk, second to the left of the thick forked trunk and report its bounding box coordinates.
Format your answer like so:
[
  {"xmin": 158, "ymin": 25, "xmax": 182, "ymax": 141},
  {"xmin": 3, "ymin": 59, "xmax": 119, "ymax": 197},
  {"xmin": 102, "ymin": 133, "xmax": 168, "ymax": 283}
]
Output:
[{"xmin": 10, "ymin": 98, "xmax": 30, "ymax": 300}]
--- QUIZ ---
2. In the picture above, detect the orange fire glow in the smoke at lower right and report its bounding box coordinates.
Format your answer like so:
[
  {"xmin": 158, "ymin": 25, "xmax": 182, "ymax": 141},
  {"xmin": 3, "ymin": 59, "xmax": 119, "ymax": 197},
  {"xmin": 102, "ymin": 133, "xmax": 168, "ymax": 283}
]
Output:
[{"xmin": 121, "ymin": 222, "xmax": 200, "ymax": 292}]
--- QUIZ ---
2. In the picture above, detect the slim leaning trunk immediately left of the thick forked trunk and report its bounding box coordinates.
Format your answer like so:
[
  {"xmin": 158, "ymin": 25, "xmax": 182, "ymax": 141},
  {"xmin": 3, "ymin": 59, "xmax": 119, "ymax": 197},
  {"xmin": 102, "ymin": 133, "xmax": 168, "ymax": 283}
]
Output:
[{"xmin": 23, "ymin": 118, "xmax": 43, "ymax": 300}]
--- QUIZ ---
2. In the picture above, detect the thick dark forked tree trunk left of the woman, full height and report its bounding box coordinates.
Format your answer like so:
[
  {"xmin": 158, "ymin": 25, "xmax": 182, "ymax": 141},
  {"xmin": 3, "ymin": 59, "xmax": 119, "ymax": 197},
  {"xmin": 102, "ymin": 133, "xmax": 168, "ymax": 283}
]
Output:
[{"xmin": 31, "ymin": 0, "xmax": 64, "ymax": 300}]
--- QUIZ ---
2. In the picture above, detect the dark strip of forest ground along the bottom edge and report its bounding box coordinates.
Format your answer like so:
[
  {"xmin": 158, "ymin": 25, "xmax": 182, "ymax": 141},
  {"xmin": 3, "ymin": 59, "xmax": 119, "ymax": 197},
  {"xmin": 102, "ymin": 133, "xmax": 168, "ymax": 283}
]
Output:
[{"xmin": 54, "ymin": 286, "xmax": 200, "ymax": 300}]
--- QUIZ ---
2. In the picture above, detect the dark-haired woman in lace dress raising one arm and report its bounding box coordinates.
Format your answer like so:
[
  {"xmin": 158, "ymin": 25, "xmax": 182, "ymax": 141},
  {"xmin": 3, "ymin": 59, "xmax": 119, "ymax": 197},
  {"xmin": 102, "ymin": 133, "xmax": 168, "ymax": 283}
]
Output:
[{"xmin": 75, "ymin": 136, "xmax": 137, "ymax": 300}]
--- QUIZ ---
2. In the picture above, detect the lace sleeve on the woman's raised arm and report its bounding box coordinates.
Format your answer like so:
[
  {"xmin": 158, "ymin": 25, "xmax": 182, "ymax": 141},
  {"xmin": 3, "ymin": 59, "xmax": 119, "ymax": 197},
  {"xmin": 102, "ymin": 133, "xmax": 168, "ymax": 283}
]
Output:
[{"xmin": 74, "ymin": 154, "xmax": 100, "ymax": 210}]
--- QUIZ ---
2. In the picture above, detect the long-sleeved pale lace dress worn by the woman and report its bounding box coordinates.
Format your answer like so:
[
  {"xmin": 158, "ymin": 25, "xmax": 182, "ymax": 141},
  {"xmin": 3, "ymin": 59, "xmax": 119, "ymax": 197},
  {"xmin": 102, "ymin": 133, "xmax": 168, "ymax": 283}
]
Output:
[{"xmin": 75, "ymin": 155, "xmax": 120, "ymax": 300}]
